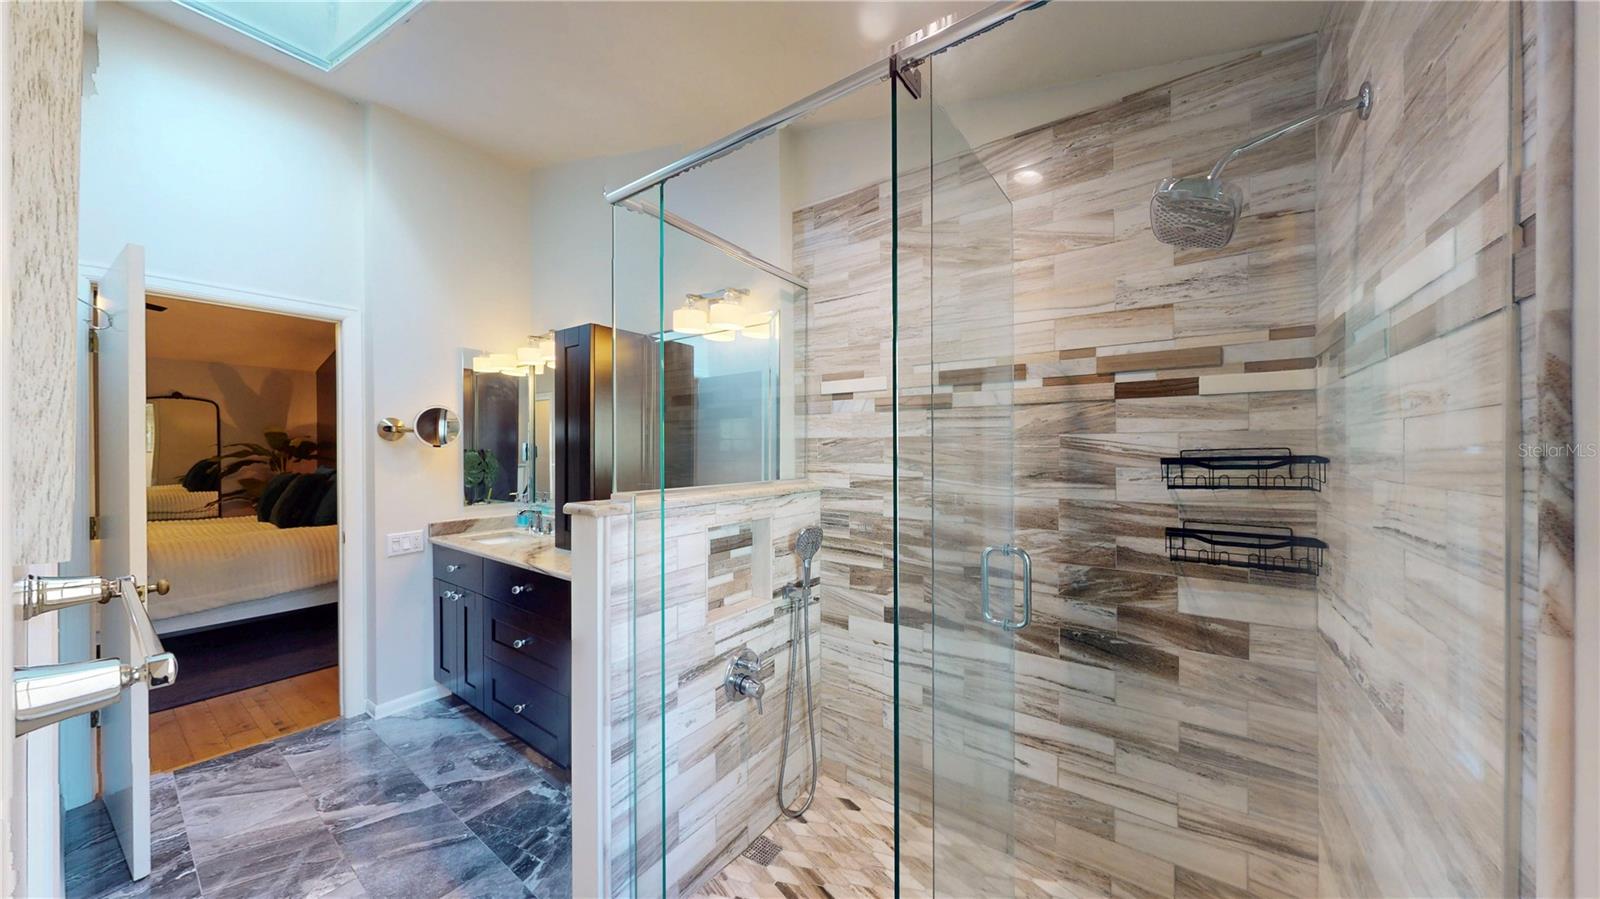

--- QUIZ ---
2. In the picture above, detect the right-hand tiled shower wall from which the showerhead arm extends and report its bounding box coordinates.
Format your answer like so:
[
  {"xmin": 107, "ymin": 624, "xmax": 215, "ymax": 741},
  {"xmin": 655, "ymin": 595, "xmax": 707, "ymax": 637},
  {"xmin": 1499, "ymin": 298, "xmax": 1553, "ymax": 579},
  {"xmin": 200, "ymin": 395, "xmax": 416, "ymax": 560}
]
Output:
[{"xmin": 1317, "ymin": 3, "xmax": 1522, "ymax": 896}]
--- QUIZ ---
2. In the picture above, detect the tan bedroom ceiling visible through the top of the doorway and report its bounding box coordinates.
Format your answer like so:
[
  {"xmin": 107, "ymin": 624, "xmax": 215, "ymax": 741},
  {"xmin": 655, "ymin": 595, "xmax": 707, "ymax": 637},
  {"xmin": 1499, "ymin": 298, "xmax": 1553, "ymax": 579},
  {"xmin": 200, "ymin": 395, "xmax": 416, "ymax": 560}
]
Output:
[{"xmin": 144, "ymin": 293, "xmax": 334, "ymax": 371}]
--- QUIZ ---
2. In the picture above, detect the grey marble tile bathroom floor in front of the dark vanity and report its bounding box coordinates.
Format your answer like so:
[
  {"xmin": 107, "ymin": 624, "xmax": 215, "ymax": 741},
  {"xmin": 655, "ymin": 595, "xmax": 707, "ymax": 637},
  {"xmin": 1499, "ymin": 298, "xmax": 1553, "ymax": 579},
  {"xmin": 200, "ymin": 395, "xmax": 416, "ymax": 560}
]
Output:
[{"xmin": 62, "ymin": 699, "xmax": 571, "ymax": 899}]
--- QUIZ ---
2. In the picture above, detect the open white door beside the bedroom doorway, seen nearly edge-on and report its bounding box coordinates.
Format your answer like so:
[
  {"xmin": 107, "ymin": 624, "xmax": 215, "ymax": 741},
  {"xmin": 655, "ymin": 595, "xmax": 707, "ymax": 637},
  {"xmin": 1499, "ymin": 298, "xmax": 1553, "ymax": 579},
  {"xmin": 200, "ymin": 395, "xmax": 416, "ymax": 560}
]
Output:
[{"xmin": 94, "ymin": 243, "xmax": 150, "ymax": 880}]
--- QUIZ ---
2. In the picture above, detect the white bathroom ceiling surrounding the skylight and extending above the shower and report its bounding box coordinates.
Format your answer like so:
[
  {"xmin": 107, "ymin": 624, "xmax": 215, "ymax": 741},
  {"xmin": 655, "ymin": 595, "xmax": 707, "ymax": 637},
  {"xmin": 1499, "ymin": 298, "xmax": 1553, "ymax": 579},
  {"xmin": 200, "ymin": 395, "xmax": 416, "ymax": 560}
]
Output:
[{"xmin": 139, "ymin": 0, "xmax": 1326, "ymax": 166}]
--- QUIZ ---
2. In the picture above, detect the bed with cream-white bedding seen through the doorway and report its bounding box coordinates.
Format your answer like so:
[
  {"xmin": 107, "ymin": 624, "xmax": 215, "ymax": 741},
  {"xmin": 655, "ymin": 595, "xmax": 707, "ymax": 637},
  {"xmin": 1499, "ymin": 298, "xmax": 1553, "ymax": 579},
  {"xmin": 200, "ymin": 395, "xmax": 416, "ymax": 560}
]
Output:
[{"xmin": 149, "ymin": 517, "xmax": 339, "ymax": 633}]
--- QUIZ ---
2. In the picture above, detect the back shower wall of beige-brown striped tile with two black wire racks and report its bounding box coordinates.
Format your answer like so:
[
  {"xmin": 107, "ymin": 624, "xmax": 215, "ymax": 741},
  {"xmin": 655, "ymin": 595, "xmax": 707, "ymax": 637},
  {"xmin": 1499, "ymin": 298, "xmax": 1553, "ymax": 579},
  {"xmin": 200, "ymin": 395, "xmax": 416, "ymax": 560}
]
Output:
[{"xmin": 794, "ymin": 38, "xmax": 1338, "ymax": 896}]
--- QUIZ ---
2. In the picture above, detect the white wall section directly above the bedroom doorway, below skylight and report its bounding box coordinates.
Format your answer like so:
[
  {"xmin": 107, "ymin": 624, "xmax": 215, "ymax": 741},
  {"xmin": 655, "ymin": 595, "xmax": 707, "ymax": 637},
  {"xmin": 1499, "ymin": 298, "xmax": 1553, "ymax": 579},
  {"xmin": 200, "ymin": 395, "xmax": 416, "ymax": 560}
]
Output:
[{"xmin": 78, "ymin": 3, "xmax": 365, "ymax": 307}]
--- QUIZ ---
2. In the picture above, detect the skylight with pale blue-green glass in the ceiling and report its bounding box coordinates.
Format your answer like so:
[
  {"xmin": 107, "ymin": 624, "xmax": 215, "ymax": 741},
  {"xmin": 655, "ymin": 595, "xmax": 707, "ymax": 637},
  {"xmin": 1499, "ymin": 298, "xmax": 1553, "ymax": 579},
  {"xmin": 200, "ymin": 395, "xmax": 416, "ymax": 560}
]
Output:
[{"xmin": 174, "ymin": 0, "xmax": 422, "ymax": 72}]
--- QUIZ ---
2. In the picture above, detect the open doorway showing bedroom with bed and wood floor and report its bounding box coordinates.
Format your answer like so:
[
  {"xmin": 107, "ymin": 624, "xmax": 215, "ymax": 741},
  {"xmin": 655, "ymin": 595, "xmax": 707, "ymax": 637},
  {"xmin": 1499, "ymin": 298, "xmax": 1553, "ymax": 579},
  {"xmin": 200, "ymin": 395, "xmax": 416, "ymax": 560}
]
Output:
[{"xmin": 144, "ymin": 293, "xmax": 339, "ymax": 773}]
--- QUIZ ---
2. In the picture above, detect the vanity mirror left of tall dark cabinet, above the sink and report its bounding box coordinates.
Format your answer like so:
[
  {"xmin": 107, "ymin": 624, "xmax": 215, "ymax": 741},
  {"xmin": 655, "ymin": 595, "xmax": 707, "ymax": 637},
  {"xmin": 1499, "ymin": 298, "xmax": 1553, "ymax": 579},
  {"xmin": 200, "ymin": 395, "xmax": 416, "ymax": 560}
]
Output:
[{"xmin": 461, "ymin": 349, "xmax": 555, "ymax": 509}]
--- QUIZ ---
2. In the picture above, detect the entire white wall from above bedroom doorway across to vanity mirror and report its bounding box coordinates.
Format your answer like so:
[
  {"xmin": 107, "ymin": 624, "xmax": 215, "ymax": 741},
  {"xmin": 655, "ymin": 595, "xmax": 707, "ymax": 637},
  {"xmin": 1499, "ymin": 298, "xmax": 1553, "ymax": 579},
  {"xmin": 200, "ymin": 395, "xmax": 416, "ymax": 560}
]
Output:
[{"xmin": 80, "ymin": 3, "xmax": 537, "ymax": 705}]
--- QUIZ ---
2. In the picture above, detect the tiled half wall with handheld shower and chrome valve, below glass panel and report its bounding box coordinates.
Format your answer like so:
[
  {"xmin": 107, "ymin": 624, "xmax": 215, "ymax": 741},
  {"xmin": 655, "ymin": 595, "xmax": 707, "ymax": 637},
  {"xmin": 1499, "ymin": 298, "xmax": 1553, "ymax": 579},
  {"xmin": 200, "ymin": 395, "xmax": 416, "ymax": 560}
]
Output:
[{"xmin": 603, "ymin": 481, "xmax": 827, "ymax": 897}]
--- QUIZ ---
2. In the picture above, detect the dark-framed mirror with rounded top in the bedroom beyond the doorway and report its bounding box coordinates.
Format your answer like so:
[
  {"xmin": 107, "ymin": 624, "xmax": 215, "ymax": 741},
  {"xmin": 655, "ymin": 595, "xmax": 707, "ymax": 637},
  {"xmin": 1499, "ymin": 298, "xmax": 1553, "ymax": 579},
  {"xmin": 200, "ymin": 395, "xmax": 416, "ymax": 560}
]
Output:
[{"xmin": 144, "ymin": 392, "xmax": 222, "ymax": 521}]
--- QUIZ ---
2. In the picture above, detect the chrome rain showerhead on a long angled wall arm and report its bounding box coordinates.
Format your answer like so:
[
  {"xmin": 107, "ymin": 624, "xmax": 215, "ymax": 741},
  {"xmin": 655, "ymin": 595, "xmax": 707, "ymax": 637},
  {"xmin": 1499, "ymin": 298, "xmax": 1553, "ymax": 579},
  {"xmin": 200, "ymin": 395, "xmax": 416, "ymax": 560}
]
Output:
[{"xmin": 1150, "ymin": 83, "xmax": 1373, "ymax": 250}]
